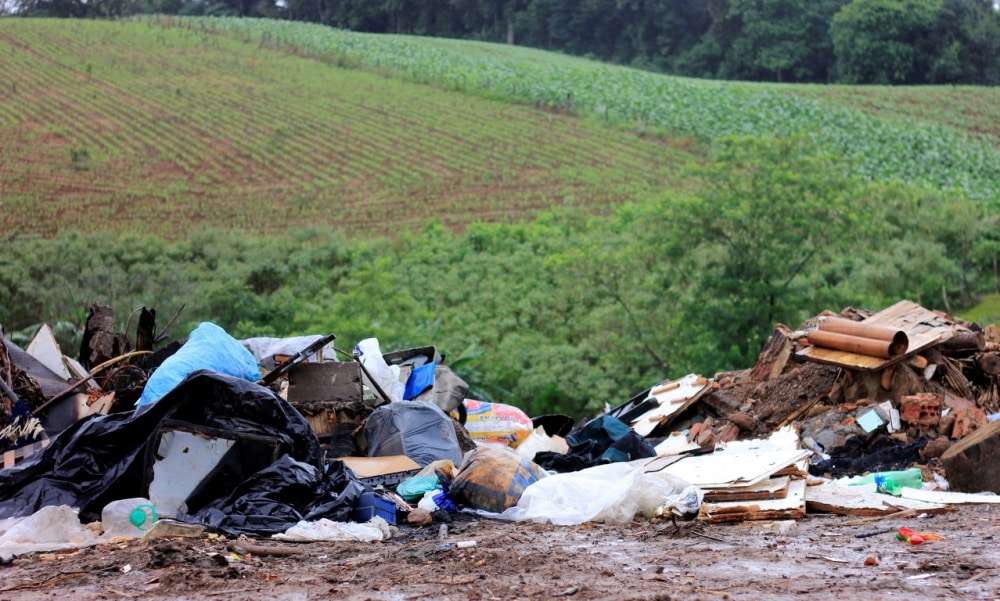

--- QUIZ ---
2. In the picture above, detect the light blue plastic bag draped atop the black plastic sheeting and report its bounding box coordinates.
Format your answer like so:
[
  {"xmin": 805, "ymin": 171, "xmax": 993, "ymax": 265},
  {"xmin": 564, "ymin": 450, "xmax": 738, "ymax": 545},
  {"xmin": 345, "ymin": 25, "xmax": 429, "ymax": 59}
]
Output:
[{"xmin": 136, "ymin": 321, "xmax": 260, "ymax": 408}]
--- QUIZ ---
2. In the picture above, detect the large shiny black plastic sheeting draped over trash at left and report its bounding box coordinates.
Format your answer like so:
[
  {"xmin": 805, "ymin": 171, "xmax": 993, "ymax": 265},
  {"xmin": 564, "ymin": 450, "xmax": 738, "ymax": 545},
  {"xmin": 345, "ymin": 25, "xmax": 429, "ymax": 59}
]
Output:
[{"xmin": 0, "ymin": 371, "xmax": 352, "ymax": 534}]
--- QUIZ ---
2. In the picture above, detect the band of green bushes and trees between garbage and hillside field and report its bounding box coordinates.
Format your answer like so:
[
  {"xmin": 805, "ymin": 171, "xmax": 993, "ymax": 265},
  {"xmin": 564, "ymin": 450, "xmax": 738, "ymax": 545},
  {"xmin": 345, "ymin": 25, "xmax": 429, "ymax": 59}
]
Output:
[{"xmin": 0, "ymin": 138, "xmax": 1000, "ymax": 414}]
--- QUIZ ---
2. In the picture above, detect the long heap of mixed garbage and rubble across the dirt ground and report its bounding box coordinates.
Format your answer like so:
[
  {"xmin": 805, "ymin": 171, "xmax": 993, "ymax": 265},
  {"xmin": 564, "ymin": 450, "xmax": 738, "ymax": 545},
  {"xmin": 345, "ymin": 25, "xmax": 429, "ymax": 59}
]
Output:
[{"xmin": 0, "ymin": 301, "xmax": 1000, "ymax": 557}]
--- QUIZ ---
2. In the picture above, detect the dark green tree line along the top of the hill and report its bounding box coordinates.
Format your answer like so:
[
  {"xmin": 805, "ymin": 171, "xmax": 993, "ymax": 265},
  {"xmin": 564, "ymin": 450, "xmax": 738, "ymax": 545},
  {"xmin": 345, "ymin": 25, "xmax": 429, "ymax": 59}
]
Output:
[{"xmin": 11, "ymin": 0, "xmax": 1000, "ymax": 85}]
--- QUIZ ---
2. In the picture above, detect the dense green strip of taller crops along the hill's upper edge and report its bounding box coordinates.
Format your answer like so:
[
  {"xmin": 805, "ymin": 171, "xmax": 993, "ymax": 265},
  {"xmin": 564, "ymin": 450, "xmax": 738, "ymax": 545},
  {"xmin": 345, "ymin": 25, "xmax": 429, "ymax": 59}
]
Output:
[{"xmin": 170, "ymin": 17, "xmax": 1000, "ymax": 205}]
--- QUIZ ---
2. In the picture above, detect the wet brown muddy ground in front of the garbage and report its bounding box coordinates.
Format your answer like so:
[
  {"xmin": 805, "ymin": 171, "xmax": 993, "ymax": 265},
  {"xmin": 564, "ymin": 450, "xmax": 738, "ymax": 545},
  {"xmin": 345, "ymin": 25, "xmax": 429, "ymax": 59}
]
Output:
[{"xmin": 0, "ymin": 506, "xmax": 1000, "ymax": 601}]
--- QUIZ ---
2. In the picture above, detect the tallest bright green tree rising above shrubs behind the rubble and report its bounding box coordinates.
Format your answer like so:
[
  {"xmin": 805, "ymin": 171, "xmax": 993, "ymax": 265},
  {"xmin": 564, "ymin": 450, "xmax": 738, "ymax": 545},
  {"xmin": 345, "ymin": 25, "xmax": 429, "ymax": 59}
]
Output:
[{"xmin": 664, "ymin": 138, "xmax": 858, "ymax": 367}]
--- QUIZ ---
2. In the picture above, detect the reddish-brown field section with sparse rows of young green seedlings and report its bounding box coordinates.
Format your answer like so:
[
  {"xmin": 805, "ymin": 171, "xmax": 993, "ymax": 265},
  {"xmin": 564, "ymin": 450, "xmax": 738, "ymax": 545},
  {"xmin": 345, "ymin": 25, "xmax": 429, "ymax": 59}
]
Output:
[{"xmin": 0, "ymin": 19, "xmax": 698, "ymax": 237}]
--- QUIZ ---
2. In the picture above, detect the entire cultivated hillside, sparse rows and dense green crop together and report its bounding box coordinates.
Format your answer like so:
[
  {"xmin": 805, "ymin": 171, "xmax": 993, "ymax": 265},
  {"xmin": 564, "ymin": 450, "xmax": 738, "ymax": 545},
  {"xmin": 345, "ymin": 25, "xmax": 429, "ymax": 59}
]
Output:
[{"xmin": 0, "ymin": 17, "xmax": 1000, "ymax": 237}]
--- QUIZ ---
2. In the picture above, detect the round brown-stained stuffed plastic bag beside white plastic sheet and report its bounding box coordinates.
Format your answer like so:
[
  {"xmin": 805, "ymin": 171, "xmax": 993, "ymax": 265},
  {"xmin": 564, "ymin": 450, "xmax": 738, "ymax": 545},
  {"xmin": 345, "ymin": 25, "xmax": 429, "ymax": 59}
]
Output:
[{"xmin": 449, "ymin": 446, "xmax": 545, "ymax": 512}]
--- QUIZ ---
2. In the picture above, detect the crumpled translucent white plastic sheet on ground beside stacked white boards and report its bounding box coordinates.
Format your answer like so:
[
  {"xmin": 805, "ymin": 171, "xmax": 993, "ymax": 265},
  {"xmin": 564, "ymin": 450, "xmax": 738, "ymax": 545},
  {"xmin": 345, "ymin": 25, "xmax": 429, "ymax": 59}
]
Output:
[{"xmin": 478, "ymin": 463, "xmax": 703, "ymax": 526}]
